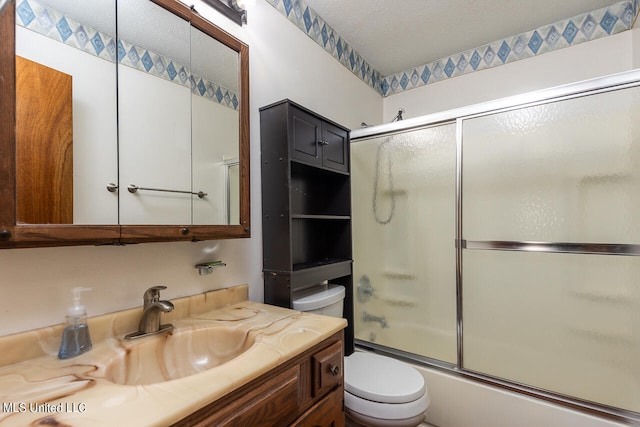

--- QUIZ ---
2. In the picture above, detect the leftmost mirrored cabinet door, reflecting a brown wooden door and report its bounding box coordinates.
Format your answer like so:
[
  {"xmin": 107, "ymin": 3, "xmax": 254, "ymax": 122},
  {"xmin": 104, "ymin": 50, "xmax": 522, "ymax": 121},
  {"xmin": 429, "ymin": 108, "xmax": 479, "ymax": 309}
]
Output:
[{"xmin": 15, "ymin": 0, "xmax": 118, "ymax": 224}]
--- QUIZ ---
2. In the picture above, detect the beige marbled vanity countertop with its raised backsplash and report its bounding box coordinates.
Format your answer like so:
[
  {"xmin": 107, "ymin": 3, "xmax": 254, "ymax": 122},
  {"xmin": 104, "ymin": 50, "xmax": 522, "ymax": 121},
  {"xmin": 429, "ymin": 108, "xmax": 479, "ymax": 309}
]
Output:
[{"xmin": 0, "ymin": 285, "xmax": 346, "ymax": 427}]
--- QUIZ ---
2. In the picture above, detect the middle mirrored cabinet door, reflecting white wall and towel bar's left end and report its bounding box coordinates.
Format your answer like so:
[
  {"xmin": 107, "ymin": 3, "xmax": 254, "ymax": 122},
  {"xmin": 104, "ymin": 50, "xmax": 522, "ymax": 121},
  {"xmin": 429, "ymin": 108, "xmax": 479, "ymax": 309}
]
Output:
[{"xmin": 118, "ymin": 0, "xmax": 191, "ymax": 225}]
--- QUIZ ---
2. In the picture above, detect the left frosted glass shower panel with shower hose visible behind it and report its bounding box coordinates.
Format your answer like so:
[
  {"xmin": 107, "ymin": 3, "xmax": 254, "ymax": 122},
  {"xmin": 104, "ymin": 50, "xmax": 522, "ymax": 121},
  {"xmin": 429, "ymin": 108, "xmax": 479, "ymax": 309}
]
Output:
[{"xmin": 351, "ymin": 123, "xmax": 457, "ymax": 363}]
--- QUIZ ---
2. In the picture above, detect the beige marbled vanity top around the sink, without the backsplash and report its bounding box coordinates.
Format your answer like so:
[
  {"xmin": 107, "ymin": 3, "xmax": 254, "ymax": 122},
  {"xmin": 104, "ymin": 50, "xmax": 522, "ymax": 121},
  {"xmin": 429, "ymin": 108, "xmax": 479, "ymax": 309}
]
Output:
[{"xmin": 0, "ymin": 286, "xmax": 346, "ymax": 427}]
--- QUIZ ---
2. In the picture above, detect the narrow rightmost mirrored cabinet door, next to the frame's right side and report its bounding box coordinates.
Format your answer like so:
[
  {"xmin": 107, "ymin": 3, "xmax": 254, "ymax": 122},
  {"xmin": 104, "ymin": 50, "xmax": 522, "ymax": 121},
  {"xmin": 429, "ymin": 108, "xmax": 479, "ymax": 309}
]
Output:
[{"xmin": 191, "ymin": 27, "xmax": 240, "ymax": 224}]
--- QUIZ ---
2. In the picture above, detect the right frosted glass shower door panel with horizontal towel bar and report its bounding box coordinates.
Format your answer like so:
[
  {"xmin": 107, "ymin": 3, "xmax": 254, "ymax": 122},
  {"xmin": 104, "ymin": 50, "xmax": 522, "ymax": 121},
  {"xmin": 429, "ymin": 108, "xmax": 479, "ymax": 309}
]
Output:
[{"xmin": 462, "ymin": 88, "xmax": 640, "ymax": 411}]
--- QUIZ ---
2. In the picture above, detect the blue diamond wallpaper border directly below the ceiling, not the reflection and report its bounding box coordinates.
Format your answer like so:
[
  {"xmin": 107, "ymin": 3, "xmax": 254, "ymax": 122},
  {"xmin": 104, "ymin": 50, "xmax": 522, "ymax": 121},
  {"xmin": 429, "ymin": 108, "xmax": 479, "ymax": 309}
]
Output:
[{"xmin": 266, "ymin": 0, "xmax": 640, "ymax": 96}]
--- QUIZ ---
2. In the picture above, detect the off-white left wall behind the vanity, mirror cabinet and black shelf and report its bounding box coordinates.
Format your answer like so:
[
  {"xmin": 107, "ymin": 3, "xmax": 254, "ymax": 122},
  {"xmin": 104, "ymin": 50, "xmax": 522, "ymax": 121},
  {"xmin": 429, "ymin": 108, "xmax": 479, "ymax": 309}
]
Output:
[{"xmin": 0, "ymin": 0, "xmax": 382, "ymax": 335}]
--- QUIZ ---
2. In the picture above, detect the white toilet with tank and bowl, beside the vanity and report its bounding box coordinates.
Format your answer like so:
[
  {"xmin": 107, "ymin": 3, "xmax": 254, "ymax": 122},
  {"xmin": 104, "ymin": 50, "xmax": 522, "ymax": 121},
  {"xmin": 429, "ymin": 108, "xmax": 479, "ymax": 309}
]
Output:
[{"xmin": 293, "ymin": 283, "xmax": 431, "ymax": 427}]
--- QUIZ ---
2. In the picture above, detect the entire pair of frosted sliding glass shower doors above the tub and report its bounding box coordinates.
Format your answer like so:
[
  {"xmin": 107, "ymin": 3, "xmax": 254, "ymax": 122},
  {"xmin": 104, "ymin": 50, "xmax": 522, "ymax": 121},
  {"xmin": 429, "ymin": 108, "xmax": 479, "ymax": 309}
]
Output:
[{"xmin": 351, "ymin": 73, "xmax": 640, "ymax": 425}]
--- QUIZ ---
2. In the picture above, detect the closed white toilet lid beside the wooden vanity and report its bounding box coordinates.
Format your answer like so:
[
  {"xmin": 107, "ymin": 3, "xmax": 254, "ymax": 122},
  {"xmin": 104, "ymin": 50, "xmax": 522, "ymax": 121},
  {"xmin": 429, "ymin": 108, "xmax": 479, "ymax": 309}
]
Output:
[{"xmin": 344, "ymin": 352, "xmax": 427, "ymax": 403}]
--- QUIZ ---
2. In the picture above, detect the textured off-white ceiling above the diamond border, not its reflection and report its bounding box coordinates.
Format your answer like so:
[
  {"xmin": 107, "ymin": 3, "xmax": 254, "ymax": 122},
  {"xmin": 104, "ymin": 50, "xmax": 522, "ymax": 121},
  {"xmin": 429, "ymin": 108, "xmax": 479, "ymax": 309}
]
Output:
[{"xmin": 305, "ymin": 0, "xmax": 619, "ymax": 76}]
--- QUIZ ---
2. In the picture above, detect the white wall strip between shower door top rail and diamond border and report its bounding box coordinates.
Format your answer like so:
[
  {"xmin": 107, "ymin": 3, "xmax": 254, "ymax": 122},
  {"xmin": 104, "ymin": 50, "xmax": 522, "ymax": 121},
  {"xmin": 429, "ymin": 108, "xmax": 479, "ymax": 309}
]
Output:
[{"xmin": 383, "ymin": 27, "xmax": 640, "ymax": 123}]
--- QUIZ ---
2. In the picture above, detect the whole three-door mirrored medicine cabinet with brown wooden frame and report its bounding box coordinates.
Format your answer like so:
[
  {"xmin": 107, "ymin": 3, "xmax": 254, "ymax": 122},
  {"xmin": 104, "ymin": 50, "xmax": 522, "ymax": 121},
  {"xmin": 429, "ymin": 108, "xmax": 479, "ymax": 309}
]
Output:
[{"xmin": 0, "ymin": 0, "xmax": 250, "ymax": 247}]
